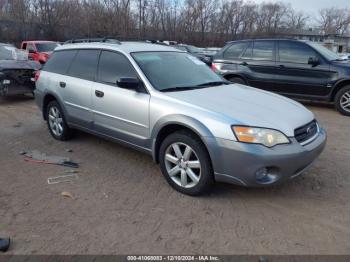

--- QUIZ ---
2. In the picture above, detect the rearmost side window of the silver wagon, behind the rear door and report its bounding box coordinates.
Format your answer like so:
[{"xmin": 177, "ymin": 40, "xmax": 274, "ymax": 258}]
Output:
[{"xmin": 43, "ymin": 50, "xmax": 77, "ymax": 75}]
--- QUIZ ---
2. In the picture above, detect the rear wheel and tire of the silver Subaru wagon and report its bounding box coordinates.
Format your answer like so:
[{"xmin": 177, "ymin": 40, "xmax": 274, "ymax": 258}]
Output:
[{"xmin": 46, "ymin": 101, "xmax": 72, "ymax": 141}]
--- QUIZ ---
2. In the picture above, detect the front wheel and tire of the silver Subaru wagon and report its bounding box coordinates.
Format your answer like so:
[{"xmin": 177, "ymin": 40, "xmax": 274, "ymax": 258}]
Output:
[{"xmin": 159, "ymin": 131, "xmax": 214, "ymax": 196}]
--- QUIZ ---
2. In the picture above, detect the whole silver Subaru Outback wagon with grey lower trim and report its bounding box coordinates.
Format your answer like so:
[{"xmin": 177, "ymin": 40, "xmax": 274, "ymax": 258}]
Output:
[{"xmin": 35, "ymin": 42, "xmax": 326, "ymax": 195}]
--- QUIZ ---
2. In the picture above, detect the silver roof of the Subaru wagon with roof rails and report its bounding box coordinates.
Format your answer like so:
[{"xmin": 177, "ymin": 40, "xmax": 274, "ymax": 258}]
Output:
[{"xmin": 55, "ymin": 42, "xmax": 181, "ymax": 54}]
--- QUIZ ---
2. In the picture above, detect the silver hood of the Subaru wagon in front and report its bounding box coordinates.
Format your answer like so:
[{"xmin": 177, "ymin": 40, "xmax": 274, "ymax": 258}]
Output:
[{"xmin": 164, "ymin": 84, "xmax": 314, "ymax": 137}]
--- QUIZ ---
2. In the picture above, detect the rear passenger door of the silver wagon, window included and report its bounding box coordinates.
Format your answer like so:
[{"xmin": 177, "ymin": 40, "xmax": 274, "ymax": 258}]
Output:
[{"xmin": 61, "ymin": 49, "xmax": 100, "ymax": 128}]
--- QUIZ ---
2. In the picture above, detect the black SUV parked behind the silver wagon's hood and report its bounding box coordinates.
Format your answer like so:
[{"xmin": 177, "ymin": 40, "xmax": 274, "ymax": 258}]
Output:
[{"xmin": 212, "ymin": 39, "xmax": 350, "ymax": 116}]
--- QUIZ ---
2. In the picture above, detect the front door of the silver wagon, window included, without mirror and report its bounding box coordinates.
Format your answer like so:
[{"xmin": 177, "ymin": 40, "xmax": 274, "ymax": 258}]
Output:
[{"xmin": 92, "ymin": 51, "xmax": 150, "ymax": 147}]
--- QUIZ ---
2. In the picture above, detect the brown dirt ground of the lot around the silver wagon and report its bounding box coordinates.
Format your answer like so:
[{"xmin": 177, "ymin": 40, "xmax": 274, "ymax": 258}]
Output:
[{"xmin": 0, "ymin": 97, "xmax": 350, "ymax": 254}]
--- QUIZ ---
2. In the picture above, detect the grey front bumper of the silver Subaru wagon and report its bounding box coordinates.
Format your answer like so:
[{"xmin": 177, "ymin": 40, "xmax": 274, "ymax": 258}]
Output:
[{"xmin": 205, "ymin": 129, "xmax": 327, "ymax": 187}]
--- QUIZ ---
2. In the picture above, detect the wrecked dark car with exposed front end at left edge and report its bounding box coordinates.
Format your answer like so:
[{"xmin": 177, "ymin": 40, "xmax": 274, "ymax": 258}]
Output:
[{"xmin": 0, "ymin": 43, "xmax": 41, "ymax": 96}]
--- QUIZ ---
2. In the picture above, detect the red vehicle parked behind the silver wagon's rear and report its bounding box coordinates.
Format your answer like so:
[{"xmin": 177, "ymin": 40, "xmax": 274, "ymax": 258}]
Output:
[{"xmin": 21, "ymin": 41, "xmax": 59, "ymax": 64}]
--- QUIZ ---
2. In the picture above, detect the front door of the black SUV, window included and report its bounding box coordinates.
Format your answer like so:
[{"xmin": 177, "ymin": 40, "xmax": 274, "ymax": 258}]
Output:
[{"xmin": 274, "ymin": 40, "xmax": 333, "ymax": 96}]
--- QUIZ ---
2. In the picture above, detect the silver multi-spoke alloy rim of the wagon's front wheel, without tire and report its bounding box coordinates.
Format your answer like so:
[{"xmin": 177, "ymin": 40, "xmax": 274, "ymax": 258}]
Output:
[{"xmin": 165, "ymin": 143, "xmax": 201, "ymax": 188}]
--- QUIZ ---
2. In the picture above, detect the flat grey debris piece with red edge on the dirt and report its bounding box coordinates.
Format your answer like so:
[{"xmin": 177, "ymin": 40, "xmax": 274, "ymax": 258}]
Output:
[{"xmin": 20, "ymin": 150, "xmax": 79, "ymax": 168}]
